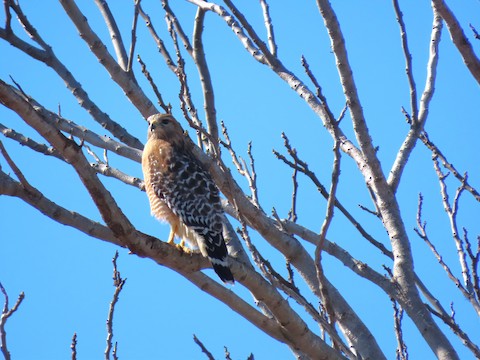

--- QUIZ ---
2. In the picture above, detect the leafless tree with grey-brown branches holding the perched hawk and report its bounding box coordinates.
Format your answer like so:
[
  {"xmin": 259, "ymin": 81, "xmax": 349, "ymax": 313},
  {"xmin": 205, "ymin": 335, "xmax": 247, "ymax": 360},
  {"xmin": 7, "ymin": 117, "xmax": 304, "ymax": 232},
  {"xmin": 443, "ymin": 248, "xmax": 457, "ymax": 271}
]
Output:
[{"xmin": 0, "ymin": 0, "xmax": 480, "ymax": 359}]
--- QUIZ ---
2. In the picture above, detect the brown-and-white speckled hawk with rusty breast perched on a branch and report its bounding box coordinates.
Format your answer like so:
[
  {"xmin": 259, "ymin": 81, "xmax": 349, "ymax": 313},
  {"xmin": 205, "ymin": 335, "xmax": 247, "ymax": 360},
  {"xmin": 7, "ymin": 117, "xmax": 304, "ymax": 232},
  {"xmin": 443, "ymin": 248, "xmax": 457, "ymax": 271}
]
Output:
[{"xmin": 142, "ymin": 114, "xmax": 234, "ymax": 283}]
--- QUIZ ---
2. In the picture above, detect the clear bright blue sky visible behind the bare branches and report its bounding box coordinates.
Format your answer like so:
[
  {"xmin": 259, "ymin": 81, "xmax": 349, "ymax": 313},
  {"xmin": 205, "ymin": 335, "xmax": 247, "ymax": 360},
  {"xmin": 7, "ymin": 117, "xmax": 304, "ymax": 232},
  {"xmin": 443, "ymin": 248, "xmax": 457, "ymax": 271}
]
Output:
[{"xmin": 0, "ymin": 0, "xmax": 480, "ymax": 359}]
